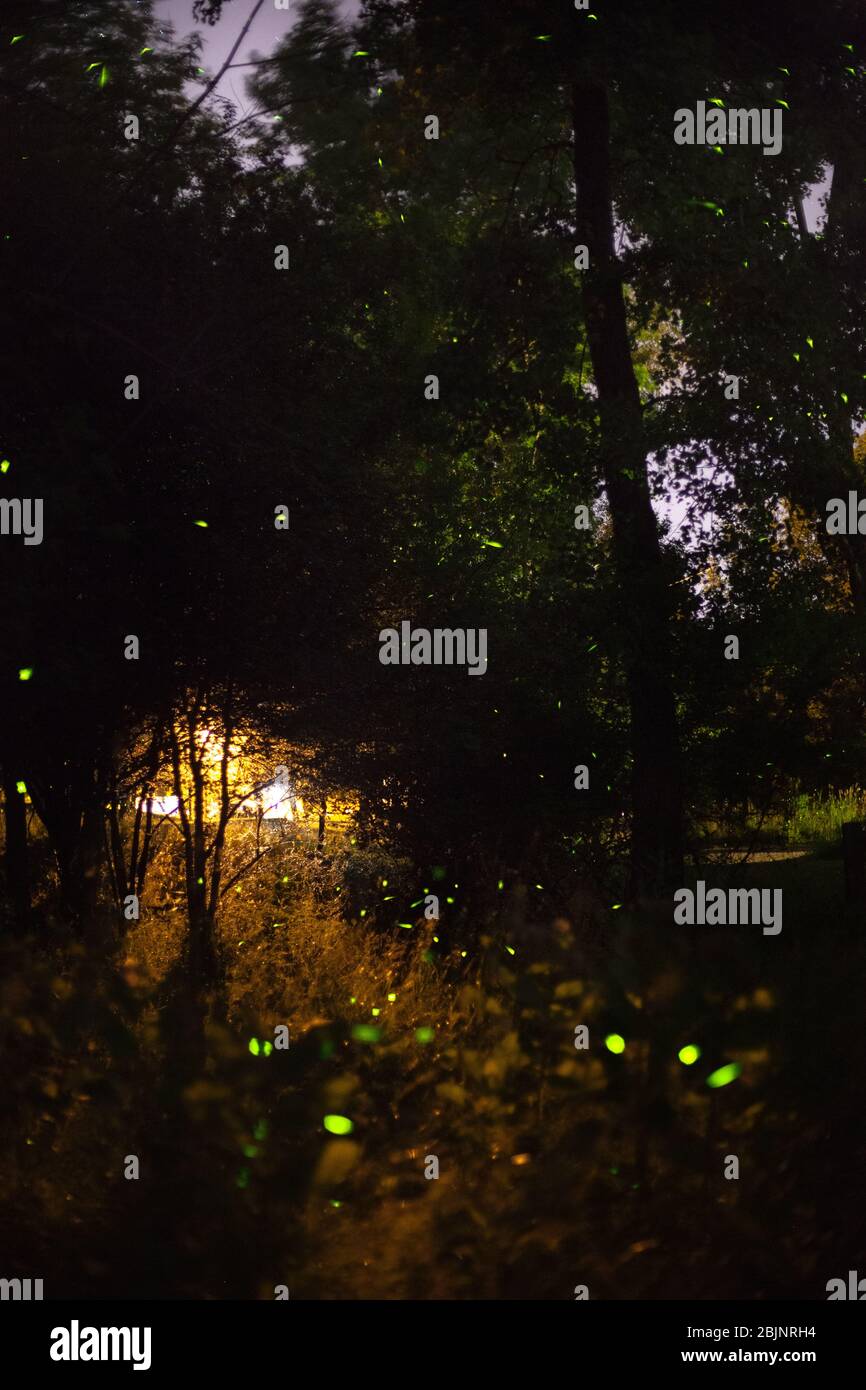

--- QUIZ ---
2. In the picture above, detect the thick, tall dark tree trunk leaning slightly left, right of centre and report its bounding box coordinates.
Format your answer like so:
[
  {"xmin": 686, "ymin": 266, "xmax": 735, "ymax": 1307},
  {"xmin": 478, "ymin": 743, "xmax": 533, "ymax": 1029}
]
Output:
[{"xmin": 573, "ymin": 83, "xmax": 683, "ymax": 894}]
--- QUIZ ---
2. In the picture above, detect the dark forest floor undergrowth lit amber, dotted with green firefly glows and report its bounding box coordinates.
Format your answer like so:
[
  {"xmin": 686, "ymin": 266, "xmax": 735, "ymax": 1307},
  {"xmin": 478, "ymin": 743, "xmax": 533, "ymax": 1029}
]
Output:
[{"xmin": 0, "ymin": 853, "xmax": 866, "ymax": 1300}]
